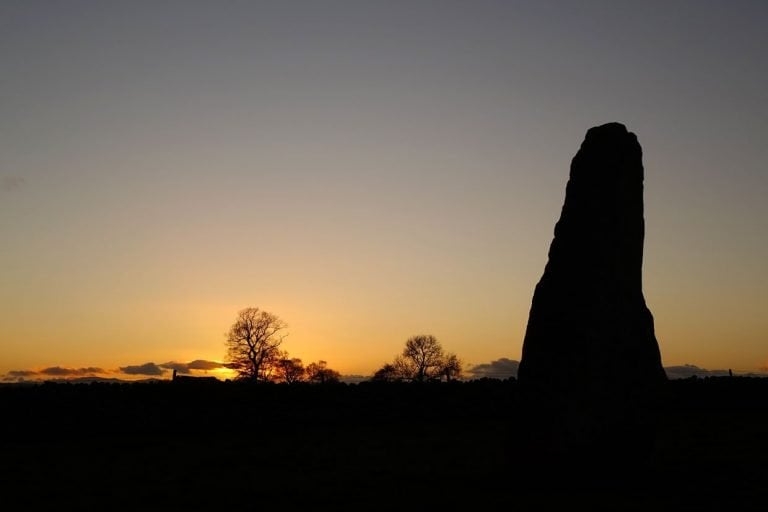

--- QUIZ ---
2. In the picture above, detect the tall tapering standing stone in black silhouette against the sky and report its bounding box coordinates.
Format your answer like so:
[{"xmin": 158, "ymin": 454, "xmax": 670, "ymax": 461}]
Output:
[{"xmin": 518, "ymin": 123, "xmax": 666, "ymax": 404}]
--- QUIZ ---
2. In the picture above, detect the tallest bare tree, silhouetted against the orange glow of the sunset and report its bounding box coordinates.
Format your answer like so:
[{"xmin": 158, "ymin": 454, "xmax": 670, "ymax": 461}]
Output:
[{"xmin": 226, "ymin": 308, "xmax": 287, "ymax": 381}]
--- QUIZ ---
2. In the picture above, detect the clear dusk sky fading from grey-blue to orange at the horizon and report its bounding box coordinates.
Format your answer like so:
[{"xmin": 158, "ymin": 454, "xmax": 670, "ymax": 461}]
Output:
[{"xmin": 0, "ymin": 0, "xmax": 768, "ymax": 376}]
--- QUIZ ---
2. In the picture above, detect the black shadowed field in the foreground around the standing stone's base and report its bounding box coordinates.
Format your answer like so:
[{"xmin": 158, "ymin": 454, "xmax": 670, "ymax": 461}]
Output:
[{"xmin": 0, "ymin": 377, "xmax": 768, "ymax": 511}]
